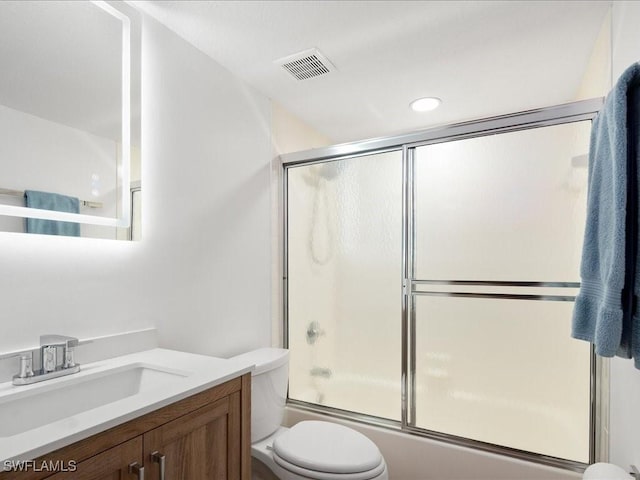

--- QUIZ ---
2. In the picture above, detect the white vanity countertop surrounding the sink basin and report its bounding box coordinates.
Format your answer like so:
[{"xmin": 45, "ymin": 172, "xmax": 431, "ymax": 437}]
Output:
[{"xmin": 0, "ymin": 348, "xmax": 253, "ymax": 464}]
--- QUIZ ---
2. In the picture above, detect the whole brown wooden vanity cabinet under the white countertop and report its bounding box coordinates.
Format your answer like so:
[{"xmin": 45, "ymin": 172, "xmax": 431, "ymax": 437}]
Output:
[{"xmin": 0, "ymin": 373, "xmax": 251, "ymax": 480}]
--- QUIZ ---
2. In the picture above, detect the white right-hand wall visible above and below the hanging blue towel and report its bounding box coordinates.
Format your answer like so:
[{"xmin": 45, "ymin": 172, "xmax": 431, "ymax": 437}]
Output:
[{"xmin": 609, "ymin": 1, "xmax": 640, "ymax": 467}]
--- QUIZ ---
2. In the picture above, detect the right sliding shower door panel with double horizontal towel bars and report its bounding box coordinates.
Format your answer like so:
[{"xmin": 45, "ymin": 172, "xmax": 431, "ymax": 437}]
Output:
[{"xmin": 411, "ymin": 122, "xmax": 591, "ymax": 462}]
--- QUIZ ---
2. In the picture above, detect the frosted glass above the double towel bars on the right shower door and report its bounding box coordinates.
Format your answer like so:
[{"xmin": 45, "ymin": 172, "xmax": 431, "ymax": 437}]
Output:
[{"xmin": 415, "ymin": 121, "xmax": 591, "ymax": 282}]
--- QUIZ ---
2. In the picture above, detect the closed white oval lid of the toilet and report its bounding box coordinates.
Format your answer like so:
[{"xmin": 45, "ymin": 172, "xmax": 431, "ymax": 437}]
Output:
[{"xmin": 273, "ymin": 421, "xmax": 382, "ymax": 474}]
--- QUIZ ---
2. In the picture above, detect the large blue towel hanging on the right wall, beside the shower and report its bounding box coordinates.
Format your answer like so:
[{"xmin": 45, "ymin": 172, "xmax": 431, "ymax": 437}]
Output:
[{"xmin": 571, "ymin": 63, "xmax": 640, "ymax": 368}]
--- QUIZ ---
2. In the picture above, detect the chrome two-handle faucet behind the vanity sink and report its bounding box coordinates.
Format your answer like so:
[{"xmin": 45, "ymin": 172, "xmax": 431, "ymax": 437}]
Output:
[{"xmin": 0, "ymin": 335, "xmax": 89, "ymax": 385}]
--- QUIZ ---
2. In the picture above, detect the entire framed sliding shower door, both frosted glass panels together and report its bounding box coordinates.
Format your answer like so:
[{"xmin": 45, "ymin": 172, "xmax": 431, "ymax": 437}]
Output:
[{"xmin": 284, "ymin": 102, "xmax": 596, "ymax": 465}]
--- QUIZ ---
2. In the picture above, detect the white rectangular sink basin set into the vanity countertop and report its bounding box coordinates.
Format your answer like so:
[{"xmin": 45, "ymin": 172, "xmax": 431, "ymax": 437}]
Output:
[{"xmin": 0, "ymin": 364, "xmax": 188, "ymax": 437}]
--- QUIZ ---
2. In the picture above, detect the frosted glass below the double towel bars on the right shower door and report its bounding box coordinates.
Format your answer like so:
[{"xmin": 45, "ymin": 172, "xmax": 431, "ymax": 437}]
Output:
[{"xmin": 415, "ymin": 296, "xmax": 590, "ymax": 462}]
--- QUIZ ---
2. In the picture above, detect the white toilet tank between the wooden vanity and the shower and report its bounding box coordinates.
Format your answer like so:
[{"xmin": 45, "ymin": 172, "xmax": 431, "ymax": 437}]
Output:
[{"xmin": 230, "ymin": 348, "xmax": 289, "ymax": 443}]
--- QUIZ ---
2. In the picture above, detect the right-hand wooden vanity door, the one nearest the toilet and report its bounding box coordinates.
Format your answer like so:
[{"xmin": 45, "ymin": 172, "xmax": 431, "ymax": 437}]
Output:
[{"xmin": 144, "ymin": 392, "xmax": 241, "ymax": 480}]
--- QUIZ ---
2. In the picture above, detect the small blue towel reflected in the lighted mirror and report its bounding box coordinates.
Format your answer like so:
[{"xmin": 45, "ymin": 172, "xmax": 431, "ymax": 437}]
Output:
[{"xmin": 24, "ymin": 190, "xmax": 80, "ymax": 237}]
